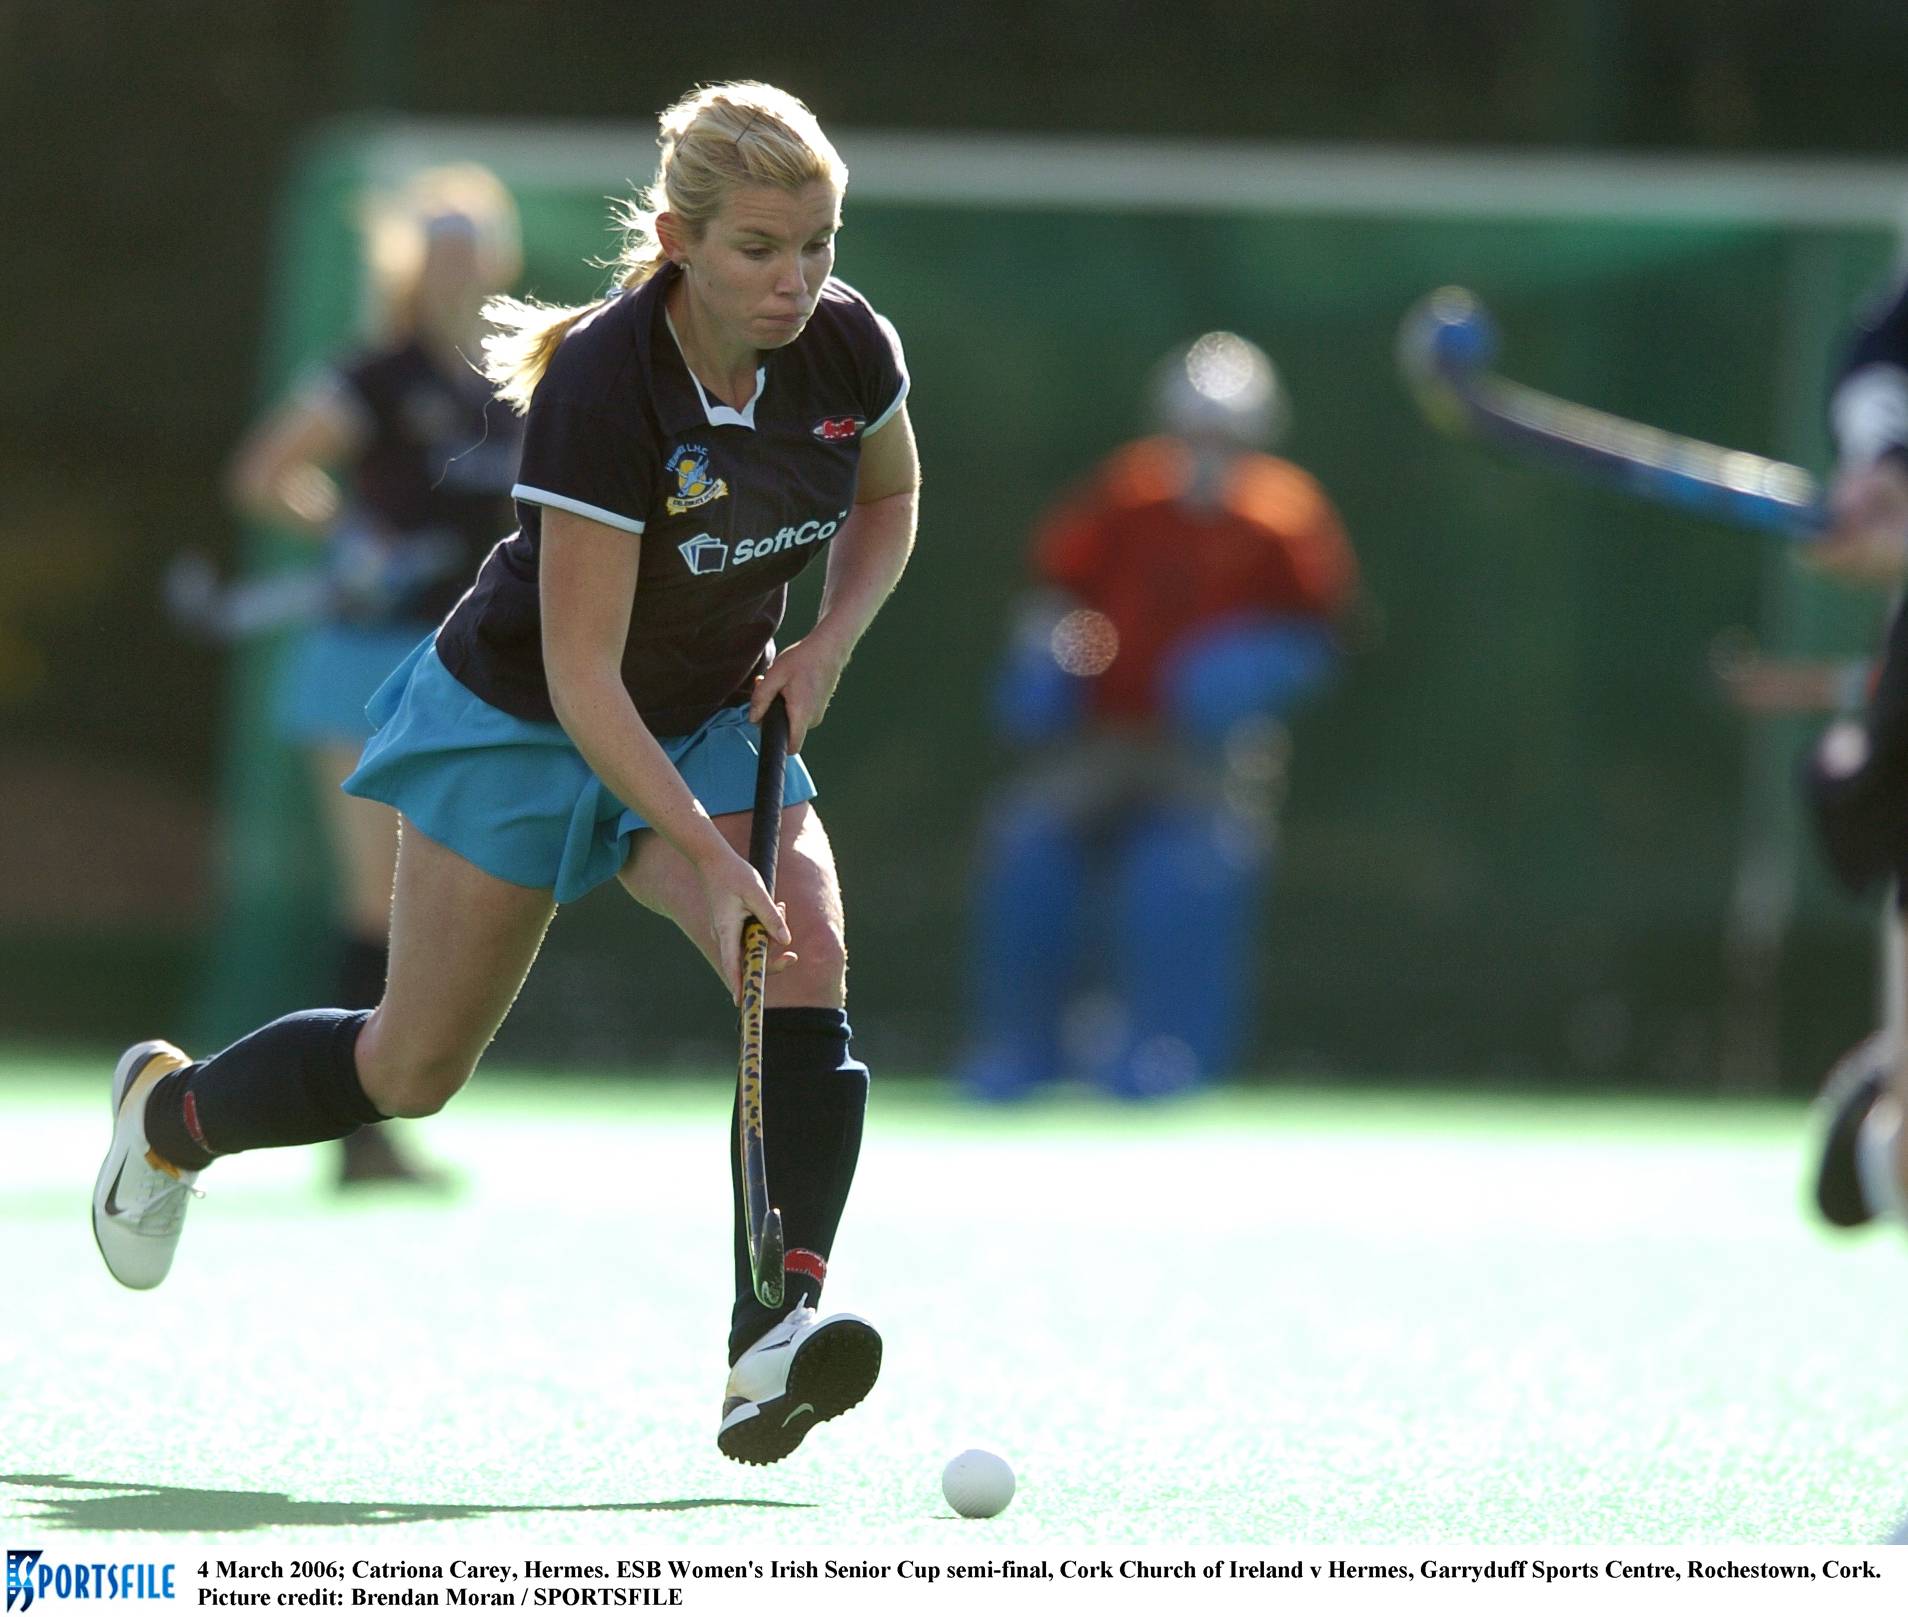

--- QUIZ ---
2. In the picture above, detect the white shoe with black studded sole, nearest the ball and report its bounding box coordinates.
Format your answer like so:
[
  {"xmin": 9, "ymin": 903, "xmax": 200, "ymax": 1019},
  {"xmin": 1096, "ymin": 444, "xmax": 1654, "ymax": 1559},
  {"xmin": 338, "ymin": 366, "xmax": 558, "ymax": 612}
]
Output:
[{"xmin": 716, "ymin": 1308, "xmax": 881, "ymax": 1466}]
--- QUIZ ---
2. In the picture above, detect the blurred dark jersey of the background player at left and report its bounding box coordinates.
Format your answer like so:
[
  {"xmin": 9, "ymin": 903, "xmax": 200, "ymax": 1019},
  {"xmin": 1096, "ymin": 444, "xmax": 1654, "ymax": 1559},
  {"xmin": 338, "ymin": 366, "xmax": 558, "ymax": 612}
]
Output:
[{"xmin": 332, "ymin": 342, "xmax": 523, "ymax": 628}]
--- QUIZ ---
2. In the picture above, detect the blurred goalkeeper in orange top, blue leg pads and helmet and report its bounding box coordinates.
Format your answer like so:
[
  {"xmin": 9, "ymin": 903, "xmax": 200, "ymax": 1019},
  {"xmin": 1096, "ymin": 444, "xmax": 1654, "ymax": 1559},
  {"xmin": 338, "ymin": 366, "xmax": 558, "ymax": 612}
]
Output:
[{"xmin": 960, "ymin": 332, "xmax": 1357, "ymax": 1100}]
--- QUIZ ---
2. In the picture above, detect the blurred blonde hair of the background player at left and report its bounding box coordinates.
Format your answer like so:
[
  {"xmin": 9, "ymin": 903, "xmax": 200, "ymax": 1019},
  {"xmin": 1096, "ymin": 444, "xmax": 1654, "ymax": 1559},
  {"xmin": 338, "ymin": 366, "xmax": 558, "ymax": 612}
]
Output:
[{"xmin": 363, "ymin": 162, "xmax": 523, "ymax": 336}]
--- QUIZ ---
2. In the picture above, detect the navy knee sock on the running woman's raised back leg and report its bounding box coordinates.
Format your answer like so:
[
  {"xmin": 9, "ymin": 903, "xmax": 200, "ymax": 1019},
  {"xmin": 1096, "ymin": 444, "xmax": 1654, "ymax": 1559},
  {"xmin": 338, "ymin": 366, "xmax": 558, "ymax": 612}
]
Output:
[{"xmin": 145, "ymin": 1010, "xmax": 384, "ymax": 1168}]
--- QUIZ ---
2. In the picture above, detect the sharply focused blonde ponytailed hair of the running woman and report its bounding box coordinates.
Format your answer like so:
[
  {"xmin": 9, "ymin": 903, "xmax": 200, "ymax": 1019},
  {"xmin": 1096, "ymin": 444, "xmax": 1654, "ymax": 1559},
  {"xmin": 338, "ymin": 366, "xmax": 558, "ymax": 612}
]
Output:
[{"xmin": 483, "ymin": 82, "xmax": 847, "ymax": 410}]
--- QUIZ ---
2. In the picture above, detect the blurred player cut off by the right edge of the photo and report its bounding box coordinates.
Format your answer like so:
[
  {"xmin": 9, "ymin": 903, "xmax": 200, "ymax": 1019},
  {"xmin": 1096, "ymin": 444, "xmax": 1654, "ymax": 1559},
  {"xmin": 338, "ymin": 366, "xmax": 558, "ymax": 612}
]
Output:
[{"xmin": 1807, "ymin": 286, "xmax": 1908, "ymax": 1228}]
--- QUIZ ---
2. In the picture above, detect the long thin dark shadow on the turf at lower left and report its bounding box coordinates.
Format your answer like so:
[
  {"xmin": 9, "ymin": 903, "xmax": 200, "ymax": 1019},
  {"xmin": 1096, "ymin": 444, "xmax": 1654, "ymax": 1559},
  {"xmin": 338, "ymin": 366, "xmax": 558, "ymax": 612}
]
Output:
[{"xmin": 0, "ymin": 1472, "xmax": 815, "ymax": 1533}]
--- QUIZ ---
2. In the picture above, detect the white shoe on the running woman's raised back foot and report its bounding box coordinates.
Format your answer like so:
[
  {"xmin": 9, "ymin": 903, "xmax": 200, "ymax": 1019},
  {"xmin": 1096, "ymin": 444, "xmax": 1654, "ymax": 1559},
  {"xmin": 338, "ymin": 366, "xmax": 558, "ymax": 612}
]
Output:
[{"xmin": 93, "ymin": 1039, "xmax": 200, "ymax": 1291}]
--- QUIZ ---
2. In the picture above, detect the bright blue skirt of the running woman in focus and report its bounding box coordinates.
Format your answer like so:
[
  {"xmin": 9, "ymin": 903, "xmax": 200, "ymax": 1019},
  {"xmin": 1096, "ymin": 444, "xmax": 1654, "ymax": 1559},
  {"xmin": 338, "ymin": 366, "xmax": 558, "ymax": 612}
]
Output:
[{"xmin": 343, "ymin": 636, "xmax": 815, "ymax": 903}]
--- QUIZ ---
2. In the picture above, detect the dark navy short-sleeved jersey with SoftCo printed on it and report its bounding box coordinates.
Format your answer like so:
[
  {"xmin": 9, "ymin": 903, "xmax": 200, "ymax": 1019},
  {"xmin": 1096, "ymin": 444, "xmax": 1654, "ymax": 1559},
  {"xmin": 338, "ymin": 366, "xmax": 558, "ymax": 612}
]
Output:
[{"xmin": 437, "ymin": 265, "xmax": 908, "ymax": 735}]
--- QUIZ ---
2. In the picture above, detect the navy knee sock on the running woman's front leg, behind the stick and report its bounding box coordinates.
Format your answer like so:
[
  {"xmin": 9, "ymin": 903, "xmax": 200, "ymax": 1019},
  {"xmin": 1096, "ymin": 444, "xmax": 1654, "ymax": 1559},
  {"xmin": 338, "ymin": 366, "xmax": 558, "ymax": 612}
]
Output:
[{"xmin": 729, "ymin": 1006, "xmax": 868, "ymax": 1363}]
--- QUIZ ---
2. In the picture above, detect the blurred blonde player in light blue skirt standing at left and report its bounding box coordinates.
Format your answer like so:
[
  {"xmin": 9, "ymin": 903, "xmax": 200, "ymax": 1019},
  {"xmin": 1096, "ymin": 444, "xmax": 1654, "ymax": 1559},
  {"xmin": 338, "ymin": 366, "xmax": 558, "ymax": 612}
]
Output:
[{"xmin": 231, "ymin": 164, "xmax": 523, "ymax": 1186}]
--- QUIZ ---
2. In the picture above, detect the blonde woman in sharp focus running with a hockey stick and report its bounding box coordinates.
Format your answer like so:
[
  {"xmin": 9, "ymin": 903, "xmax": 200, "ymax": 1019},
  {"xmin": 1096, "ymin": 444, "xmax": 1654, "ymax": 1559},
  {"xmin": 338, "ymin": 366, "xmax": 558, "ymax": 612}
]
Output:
[{"xmin": 93, "ymin": 84, "xmax": 920, "ymax": 1464}]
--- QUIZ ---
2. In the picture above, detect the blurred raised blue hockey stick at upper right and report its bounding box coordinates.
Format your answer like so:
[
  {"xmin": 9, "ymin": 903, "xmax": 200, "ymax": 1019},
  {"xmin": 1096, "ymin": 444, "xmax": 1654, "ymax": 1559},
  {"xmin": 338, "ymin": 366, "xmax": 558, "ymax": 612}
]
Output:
[{"xmin": 1399, "ymin": 286, "xmax": 1828, "ymax": 538}]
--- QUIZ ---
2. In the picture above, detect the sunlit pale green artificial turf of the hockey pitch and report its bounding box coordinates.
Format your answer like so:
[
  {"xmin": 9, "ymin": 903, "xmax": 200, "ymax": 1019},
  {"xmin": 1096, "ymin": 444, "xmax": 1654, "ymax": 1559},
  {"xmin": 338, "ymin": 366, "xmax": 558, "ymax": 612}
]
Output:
[{"xmin": 0, "ymin": 1056, "xmax": 1908, "ymax": 1556}]
